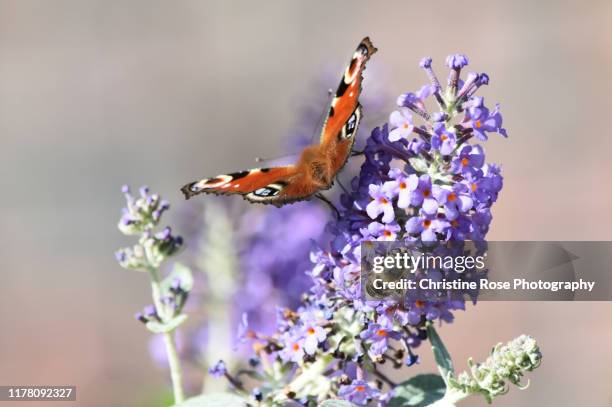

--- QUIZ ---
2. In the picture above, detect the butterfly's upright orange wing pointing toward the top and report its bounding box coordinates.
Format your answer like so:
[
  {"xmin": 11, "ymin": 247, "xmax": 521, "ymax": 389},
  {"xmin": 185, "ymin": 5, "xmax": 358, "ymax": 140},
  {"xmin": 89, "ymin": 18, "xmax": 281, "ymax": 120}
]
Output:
[{"xmin": 320, "ymin": 37, "xmax": 377, "ymax": 146}]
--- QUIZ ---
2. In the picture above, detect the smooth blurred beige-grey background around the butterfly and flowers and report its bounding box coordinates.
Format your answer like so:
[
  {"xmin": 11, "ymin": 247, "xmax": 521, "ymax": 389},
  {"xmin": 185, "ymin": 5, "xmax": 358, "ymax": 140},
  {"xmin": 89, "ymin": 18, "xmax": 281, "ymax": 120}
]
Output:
[{"xmin": 0, "ymin": 0, "xmax": 612, "ymax": 406}]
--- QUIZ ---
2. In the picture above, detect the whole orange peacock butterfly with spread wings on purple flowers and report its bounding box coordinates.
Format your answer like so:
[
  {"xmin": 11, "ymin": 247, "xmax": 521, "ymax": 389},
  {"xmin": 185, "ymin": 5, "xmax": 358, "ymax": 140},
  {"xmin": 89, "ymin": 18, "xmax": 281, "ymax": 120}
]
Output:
[{"xmin": 181, "ymin": 37, "xmax": 376, "ymax": 206}]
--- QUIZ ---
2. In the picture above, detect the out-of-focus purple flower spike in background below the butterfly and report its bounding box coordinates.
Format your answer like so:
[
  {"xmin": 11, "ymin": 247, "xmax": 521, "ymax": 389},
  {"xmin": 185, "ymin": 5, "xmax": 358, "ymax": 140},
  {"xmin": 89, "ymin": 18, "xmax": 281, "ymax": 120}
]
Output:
[{"xmin": 233, "ymin": 202, "xmax": 328, "ymax": 333}]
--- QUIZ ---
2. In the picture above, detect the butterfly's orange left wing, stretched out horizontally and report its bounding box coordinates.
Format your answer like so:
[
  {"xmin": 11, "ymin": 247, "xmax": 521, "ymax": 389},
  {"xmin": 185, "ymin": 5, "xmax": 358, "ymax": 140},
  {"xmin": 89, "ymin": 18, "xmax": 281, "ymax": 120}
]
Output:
[{"xmin": 181, "ymin": 165, "xmax": 314, "ymax": 206}]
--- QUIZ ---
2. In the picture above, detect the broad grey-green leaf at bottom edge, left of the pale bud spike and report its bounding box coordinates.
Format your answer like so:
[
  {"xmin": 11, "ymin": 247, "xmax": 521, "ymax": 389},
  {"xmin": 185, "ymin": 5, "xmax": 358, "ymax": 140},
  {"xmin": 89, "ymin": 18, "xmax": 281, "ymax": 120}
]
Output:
[{"xmin": 389, "ymin": 373, "xmax": 446, "ymax": 407}]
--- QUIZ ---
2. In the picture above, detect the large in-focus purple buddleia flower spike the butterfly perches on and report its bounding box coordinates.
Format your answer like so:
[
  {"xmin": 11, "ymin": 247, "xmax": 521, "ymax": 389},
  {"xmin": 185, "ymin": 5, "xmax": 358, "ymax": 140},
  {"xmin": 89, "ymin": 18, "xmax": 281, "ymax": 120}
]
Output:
[{"xmin": 210, "ymin": 54, "xmax": 506, "ymax": 405}]
